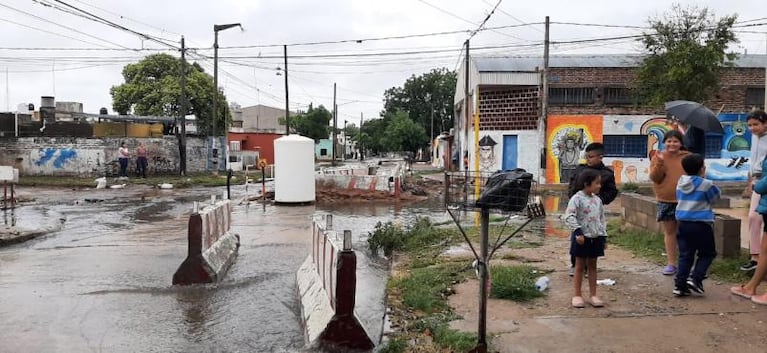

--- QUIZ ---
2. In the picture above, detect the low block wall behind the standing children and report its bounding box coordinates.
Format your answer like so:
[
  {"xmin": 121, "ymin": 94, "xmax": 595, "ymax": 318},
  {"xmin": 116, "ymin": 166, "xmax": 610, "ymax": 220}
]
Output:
[{"xmin": 620, "ymin": 193, "xmax": 741, "ymax": 257}]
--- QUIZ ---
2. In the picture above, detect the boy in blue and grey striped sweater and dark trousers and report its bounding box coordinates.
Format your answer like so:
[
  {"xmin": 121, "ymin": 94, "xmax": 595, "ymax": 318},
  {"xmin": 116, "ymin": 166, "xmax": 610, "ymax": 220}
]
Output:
[{"xmin": 673, "ymin": 153, "xmax": 722, "ymax": 297}]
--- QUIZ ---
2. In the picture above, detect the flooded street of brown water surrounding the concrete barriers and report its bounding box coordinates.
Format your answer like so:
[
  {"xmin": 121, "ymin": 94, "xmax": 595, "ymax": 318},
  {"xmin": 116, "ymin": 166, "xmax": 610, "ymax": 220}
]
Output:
[{"xmin": 0, "ymin": 185, "xmax": 445, "ymax": 352}]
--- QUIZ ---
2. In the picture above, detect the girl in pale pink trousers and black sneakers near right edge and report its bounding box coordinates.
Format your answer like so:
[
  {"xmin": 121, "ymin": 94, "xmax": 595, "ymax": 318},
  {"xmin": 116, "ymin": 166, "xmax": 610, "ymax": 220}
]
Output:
[{"xmin": 740, "ymin": 110, "xmax": 767, "ymax": 271}]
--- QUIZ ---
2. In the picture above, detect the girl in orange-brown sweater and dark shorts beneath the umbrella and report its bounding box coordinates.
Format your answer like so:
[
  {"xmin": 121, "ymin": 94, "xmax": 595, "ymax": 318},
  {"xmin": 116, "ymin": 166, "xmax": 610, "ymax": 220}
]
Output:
[{"xmin": 650, "ymin": 130, "xmax": 689, "ymax": 276}]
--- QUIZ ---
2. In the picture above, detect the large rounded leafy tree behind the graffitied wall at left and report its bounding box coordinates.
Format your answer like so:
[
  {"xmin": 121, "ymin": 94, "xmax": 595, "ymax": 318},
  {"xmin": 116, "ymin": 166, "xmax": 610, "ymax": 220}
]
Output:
[{"xmin": 110, "ymin": 54, "xmax": 232, "ymax": 135}]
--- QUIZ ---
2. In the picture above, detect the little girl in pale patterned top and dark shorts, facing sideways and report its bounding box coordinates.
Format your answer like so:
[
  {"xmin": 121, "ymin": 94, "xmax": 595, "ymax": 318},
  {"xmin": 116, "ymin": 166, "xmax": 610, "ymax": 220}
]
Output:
[{"xmin": 565, "ymin": 169, "xmax": 607, "ymax": 308}]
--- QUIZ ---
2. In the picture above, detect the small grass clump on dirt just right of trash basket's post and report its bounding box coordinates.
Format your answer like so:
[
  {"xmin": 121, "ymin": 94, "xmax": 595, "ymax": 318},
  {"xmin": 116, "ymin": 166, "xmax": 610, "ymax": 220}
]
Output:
[{"xmin": 490, "ymin": 266, "xmax": 543, "ymax": 302}]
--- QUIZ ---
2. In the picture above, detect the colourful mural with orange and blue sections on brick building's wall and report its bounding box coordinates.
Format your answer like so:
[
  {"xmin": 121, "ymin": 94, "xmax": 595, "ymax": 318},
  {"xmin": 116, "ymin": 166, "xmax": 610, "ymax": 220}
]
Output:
[{"xmin": 546, "ymin": 114, "xmax": 751, "ymax": 183}]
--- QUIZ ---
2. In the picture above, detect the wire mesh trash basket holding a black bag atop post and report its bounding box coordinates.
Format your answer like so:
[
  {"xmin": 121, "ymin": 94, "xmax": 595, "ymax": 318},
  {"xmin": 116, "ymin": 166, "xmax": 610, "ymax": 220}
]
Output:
[{"xmin": 445, "ymin": 169, "xmax": 545, "ymax": 218}]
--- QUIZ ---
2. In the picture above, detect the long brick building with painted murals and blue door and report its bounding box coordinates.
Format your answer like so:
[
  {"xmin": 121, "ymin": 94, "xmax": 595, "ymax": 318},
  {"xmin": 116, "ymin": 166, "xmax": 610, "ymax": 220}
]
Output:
[{"xmin": 455, "ymin": 55, "xmax": 767, "ymax": 183}]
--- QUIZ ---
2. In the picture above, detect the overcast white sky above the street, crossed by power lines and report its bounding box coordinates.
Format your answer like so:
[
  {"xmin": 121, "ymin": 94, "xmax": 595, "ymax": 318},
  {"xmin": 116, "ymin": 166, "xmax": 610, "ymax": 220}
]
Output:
[{"xmin": 0, "ymin": 0, "xmax": 767, "ymax": 125}]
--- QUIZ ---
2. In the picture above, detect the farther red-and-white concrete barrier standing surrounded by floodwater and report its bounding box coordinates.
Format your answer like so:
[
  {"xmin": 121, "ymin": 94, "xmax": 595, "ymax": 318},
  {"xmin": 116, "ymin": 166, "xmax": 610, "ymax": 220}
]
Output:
[{"xmin": 173, "ymin": 200, "xmax": 240, "ymax": 285}]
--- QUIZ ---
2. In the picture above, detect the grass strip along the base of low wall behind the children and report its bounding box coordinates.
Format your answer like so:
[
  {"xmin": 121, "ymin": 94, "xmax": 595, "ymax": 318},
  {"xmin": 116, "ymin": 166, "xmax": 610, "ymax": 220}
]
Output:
[{"xmin": 607, "ymin": 221, "xmax": 751, "ymax": 283}]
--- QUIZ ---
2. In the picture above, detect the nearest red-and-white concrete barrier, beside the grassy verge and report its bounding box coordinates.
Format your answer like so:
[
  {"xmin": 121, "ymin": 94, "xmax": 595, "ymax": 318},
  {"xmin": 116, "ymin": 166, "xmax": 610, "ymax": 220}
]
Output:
[{"xmin": 296, "ymin": 215, "xmax": 375, "ymax": 352}]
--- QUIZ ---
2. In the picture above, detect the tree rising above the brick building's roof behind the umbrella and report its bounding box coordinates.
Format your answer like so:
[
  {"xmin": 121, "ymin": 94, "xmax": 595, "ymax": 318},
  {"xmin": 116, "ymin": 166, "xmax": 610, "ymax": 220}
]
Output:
[{"xmin": 636, "ymin": 5, "xmax": 738, "ymax": 106}]
